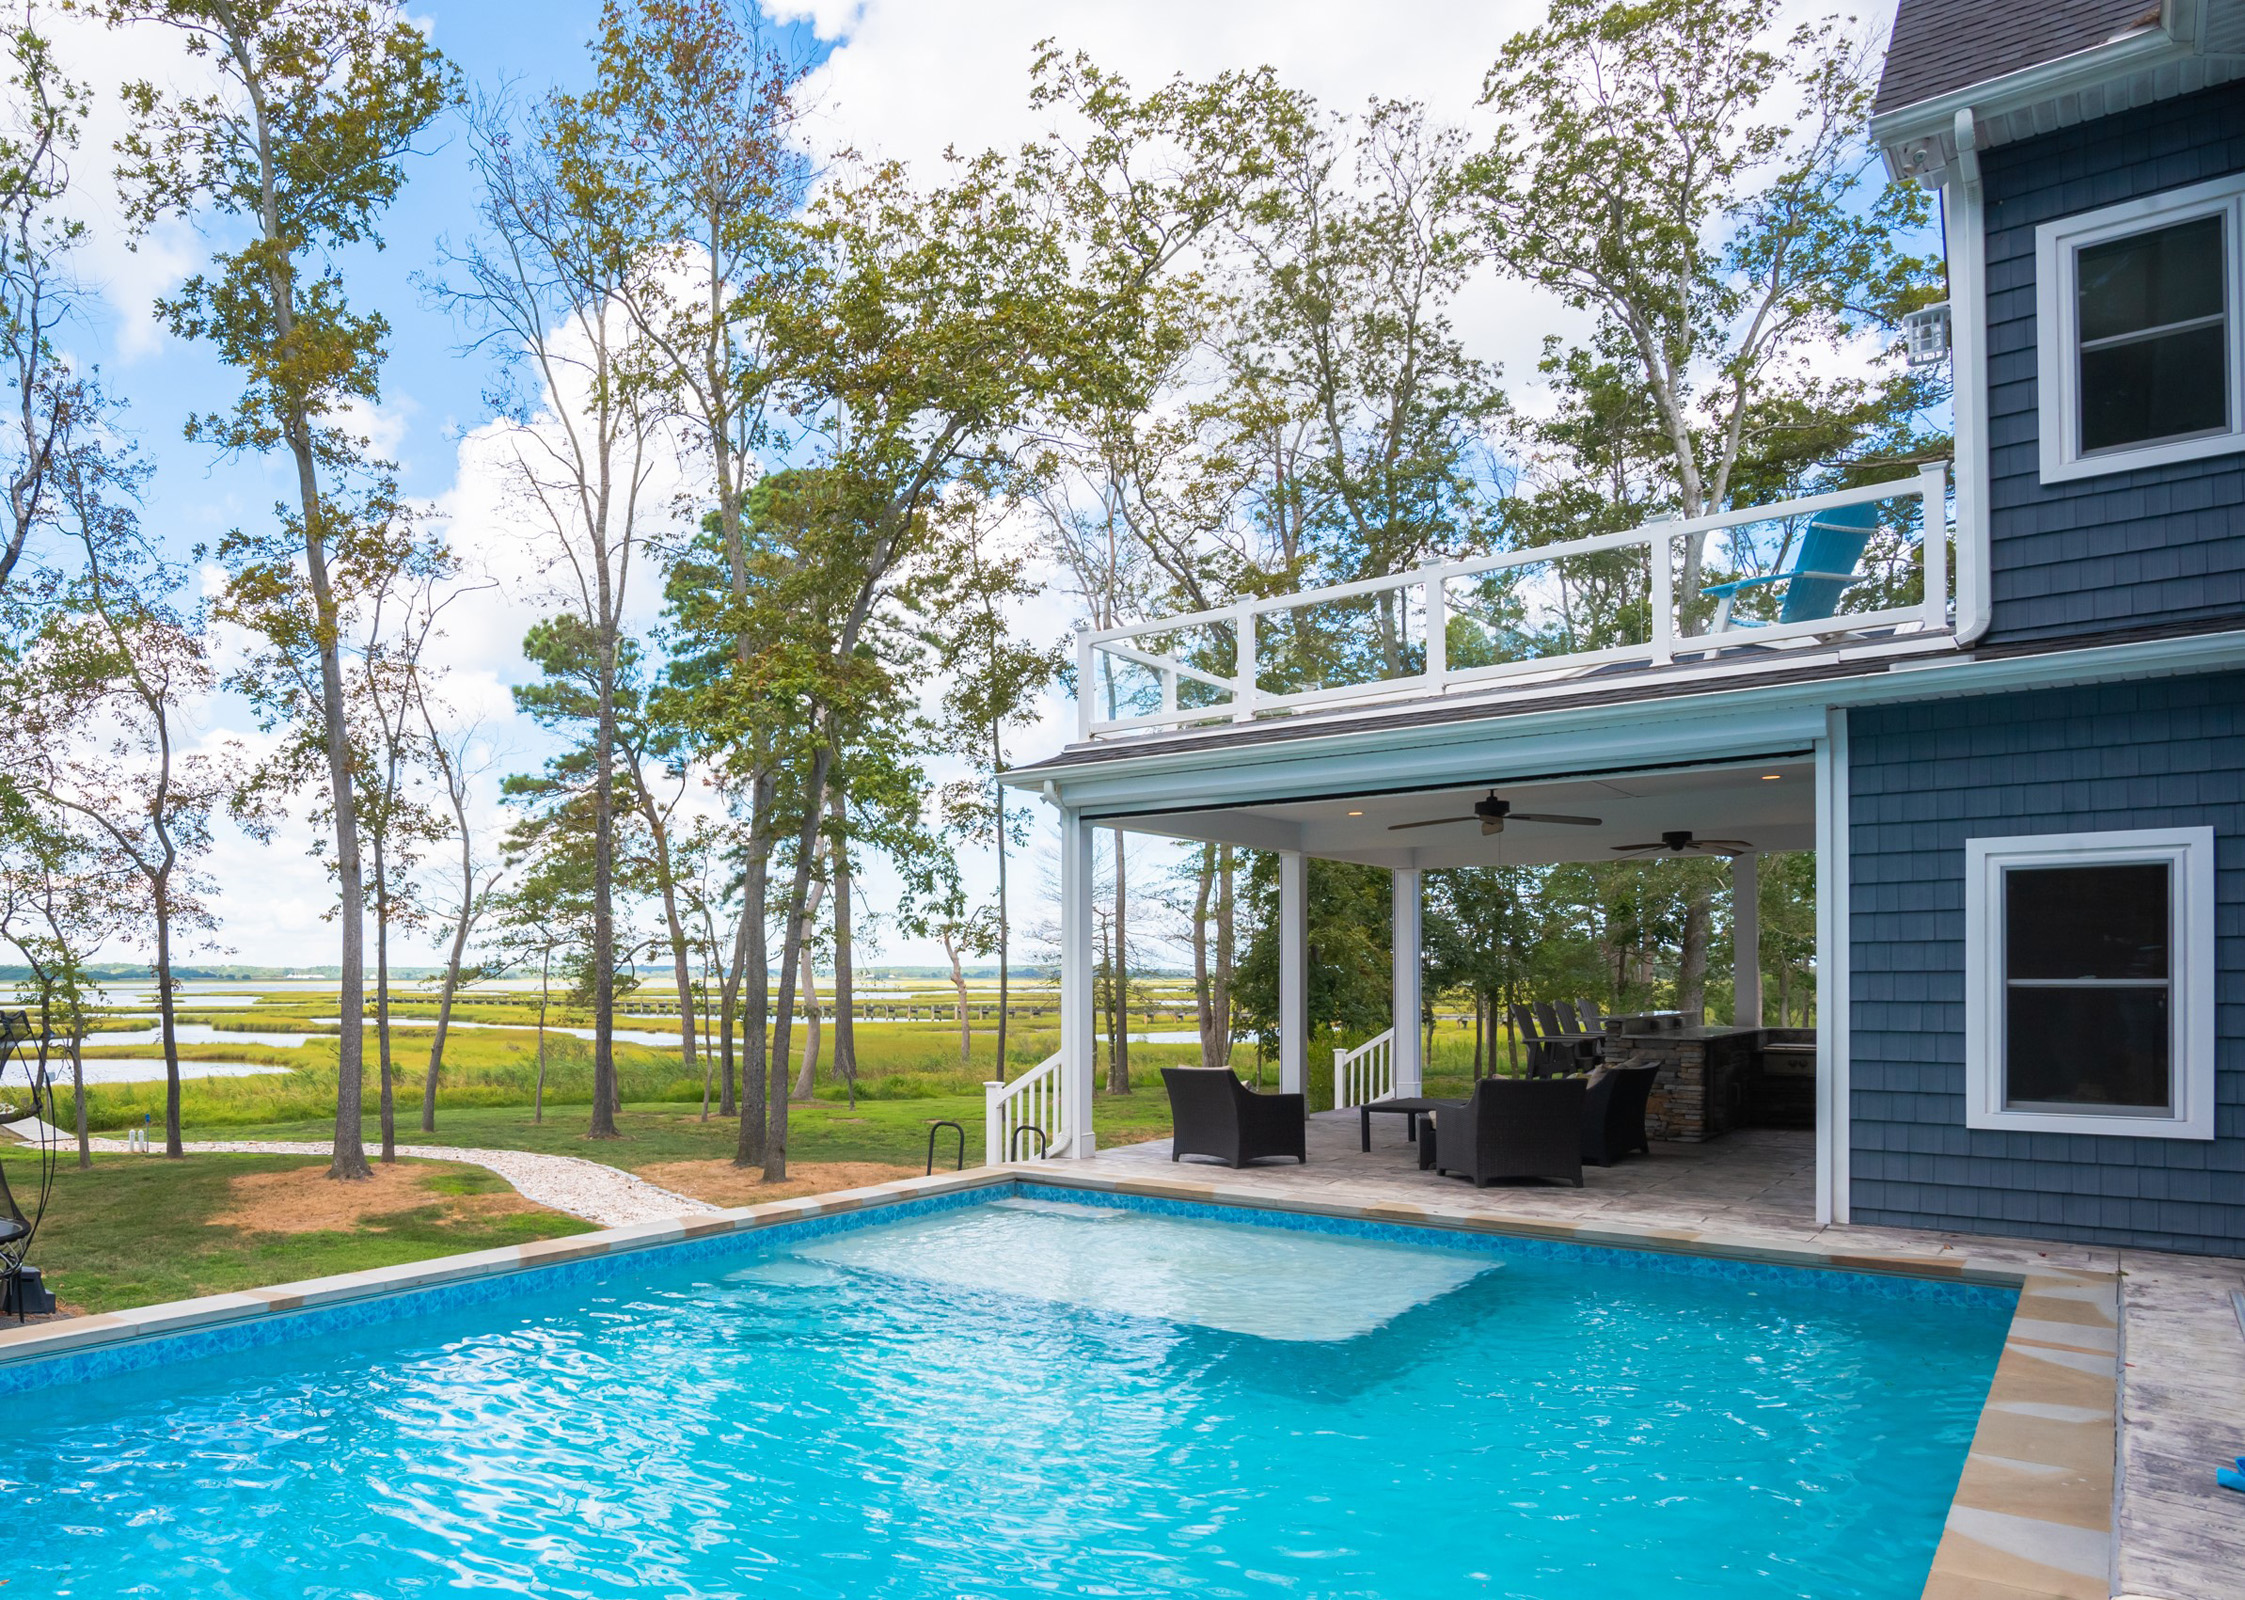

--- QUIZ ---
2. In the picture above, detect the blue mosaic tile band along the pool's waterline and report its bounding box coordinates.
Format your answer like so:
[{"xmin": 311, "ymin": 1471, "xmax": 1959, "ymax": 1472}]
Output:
[{"xmin": 0, "ymin": 1171, "xmax": 2047, "ymax": 1394}]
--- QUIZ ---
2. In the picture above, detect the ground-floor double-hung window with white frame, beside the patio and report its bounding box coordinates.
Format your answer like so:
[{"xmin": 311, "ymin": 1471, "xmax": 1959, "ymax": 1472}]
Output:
[{"xmin": 1964, "ymin": 828, "xmax": 2214, "ymax": 1140}]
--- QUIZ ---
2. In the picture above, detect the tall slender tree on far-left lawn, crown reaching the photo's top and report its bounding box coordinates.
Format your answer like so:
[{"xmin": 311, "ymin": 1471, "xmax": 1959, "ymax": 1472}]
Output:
[{"xmin": 94, "ymin": 0, "xmax": 453, "ymax": 1178}]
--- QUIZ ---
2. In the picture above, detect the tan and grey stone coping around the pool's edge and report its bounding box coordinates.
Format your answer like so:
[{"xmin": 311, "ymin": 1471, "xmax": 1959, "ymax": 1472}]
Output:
[{"xmin": 0, "ymin": 1165, "xmax": 2122, "ymax": 1600}]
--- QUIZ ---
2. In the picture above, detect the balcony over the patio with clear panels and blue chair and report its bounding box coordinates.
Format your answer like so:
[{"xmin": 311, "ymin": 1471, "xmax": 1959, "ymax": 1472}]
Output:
[{"xmin": 1075, "ymin": 462, "xmax": 1951, "ymax": 741}]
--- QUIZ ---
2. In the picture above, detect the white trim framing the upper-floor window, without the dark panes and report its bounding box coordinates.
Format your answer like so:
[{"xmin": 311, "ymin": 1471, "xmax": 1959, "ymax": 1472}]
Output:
[{"xmin": 2034, "ymin": 173, "xmax": 2245, "ymax": 482}]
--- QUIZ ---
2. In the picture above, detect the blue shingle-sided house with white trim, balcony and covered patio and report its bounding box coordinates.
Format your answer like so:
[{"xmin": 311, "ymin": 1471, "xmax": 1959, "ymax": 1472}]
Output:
[{"xmin": 992, "ymin": 0, "xmax": 2245, "ymax": 1254}]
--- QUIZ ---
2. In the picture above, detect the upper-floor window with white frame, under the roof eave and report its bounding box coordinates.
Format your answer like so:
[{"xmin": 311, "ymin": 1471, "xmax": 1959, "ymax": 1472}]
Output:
[{"xmin": 2036, "ymin": 177, "xmax": 2245, "ymax": 482}]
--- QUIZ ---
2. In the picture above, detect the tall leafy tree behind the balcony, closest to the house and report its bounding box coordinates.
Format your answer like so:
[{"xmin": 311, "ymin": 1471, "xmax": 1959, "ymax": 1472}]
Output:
[{"xmin": 1468, "ymin": 0, "xmax": 1937, "ymax": 610}]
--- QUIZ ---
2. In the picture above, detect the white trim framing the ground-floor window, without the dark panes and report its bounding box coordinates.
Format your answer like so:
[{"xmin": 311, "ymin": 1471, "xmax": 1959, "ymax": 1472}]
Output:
[{"xmin": 1964, "ymin": 828, "xmax": 2214, "ymax": 1140}]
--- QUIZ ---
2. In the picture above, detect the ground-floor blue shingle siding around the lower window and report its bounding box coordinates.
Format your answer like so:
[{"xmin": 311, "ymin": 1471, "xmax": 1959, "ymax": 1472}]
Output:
[{"xmin": 1848, "ymin": 673, "xmax": 2245, "ymax": 1254}]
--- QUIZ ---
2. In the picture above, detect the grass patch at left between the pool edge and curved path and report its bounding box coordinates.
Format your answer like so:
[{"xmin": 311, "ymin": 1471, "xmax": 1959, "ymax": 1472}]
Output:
[{"xmin": 0, "ymin": 1153, "xmax": 593, "ymax": 1313}]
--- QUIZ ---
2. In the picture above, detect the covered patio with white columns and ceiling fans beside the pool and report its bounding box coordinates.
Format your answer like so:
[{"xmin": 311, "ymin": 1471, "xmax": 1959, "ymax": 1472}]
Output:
[{"xmin": 1019, "ymin": 741, "xmax": 1834, "ymax": 1221}]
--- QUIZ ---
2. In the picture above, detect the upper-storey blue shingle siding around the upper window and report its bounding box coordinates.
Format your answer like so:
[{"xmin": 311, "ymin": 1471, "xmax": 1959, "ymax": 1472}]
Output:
[{"xmin": 1982, "ymin": 85, "xmax": 2245, "ymax": 642}]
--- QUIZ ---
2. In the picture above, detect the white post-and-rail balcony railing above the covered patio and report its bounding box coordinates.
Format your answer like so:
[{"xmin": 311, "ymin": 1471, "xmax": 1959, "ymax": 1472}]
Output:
[{"xmin": 1075, "ymin": 462, "xmax": 1949, "ymax": 741}]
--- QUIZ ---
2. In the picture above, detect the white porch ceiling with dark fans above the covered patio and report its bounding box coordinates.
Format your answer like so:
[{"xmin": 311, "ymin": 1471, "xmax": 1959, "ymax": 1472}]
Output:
[{"xmin": 1093, "ymin": 756, "xmax": 1816, "ymax": 866}]
